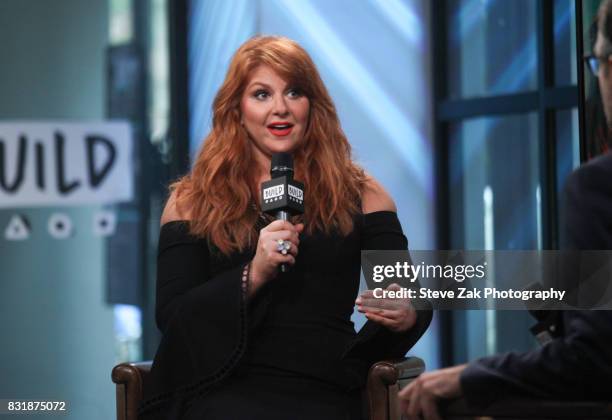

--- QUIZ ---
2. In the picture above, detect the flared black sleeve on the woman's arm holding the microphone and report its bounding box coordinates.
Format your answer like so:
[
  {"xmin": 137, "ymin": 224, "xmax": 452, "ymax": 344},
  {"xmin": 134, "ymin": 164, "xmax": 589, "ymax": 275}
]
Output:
[{"xmin": 141, "ymin": 222, "xmax": 248, "ymax": 414}]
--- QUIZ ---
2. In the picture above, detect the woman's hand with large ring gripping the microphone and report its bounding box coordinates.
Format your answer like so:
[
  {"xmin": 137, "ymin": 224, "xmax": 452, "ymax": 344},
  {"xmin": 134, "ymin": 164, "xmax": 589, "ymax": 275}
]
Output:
[{"xmin": 249, "ymin": 220, "xmax": 304, "ymax": 292}]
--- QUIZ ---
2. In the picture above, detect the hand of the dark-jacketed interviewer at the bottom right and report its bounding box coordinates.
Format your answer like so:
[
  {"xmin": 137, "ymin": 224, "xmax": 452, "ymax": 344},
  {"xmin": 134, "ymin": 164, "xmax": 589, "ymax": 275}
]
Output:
[{"xmin": 398, "ymin": 364, "xmax": 467, "ymax": 420}]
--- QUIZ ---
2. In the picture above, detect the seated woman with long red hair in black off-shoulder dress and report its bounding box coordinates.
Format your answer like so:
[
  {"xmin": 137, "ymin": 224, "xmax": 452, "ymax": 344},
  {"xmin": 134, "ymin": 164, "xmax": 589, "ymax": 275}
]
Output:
[{"xmin": 140, "ymin": 37, "xmax": 431, "ymax": 420}]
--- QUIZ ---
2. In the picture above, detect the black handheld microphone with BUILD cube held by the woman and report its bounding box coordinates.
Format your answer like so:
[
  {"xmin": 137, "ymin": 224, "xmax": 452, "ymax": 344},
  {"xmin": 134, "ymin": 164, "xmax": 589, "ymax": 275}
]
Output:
[{"xmin": 261, "ymin": 153, "xmax": 304, "ymax": 273}]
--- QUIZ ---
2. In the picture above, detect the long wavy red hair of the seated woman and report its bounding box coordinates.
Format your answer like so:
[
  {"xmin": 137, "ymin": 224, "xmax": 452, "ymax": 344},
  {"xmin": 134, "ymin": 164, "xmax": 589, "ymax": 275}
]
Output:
[{"xmin": 171, "ymin": 36, "xmax": 366, "ymax": 254}]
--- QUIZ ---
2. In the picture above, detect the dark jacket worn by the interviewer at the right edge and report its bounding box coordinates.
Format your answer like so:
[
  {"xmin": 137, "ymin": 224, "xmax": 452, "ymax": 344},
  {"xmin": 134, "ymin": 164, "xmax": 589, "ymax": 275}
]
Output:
[{"xmin": 461, "ymin": 154, "xmax": 612, "ymax": 406}]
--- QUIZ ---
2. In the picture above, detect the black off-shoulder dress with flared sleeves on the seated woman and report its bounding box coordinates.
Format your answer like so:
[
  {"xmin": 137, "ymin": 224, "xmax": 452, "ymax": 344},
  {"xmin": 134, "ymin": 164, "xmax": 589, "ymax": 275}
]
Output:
[{"xmin": 140, "ymin": 211, "xmax": 431, "ymax": 420}]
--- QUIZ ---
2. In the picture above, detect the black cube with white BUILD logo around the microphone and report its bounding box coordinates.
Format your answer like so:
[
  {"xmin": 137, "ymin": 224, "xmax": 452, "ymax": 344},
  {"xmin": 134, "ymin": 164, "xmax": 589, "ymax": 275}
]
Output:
[{"xmin": 261, "ymin": 176, "xmax": 304, "ymax": 216}]
